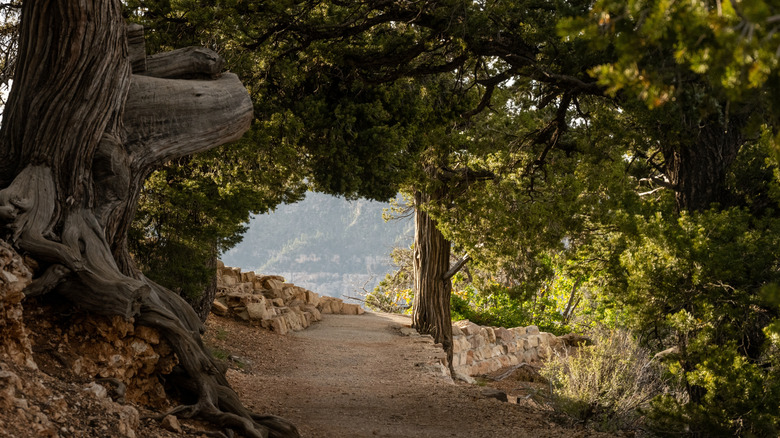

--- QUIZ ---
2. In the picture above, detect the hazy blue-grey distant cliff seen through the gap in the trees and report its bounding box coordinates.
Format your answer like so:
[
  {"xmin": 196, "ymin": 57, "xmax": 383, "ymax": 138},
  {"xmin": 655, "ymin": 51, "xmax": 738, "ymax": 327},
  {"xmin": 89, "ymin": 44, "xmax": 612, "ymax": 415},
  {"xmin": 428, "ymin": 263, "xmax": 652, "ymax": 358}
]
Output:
[{"xmin": 222, "ymin": 193, "xmax": 414, "ymax": 297}]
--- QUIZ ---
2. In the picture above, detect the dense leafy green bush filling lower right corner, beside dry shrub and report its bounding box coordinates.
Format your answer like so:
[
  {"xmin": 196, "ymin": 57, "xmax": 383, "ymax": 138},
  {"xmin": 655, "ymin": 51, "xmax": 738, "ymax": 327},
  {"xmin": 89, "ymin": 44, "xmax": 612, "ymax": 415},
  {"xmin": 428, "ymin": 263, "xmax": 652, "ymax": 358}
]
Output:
[{"xmin": 584, "ymin": 204, "xmax": 780, "ymax": 436}]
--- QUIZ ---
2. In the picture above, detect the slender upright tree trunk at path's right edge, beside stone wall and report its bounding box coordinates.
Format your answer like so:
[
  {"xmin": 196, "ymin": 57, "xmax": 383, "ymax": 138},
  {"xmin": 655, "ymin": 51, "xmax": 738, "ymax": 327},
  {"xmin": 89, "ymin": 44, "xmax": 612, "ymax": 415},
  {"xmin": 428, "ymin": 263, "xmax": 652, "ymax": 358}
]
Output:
[{"xmin": 412, "ymin": 192, "xmax": 452, "ymax": 367}]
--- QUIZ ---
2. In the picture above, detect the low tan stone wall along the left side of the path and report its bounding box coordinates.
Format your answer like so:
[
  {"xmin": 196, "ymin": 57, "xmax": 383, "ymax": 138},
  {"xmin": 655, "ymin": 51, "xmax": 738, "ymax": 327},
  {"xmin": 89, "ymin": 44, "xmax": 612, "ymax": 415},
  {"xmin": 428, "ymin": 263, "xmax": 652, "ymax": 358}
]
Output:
[{"xmin": 211, "ymin": 262, "xmax": 363, "ymax": 334}]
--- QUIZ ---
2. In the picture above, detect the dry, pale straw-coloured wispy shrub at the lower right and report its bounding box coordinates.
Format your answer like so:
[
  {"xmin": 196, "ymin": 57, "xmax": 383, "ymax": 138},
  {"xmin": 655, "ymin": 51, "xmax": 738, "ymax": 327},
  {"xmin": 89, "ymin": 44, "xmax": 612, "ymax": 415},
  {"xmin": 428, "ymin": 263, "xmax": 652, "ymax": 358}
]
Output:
[{"xmin": 540, "ymin": 330, "xmax": 666, "ymax": 432}]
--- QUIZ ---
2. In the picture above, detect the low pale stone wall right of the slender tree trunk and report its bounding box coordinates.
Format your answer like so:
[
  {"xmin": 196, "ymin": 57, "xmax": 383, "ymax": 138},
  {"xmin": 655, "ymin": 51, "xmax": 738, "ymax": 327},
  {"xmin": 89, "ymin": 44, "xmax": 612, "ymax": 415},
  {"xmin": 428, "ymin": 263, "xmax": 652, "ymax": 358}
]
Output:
[{"xmin": 452, "ymin": 320, "xmax": 570, "ymax": 377}]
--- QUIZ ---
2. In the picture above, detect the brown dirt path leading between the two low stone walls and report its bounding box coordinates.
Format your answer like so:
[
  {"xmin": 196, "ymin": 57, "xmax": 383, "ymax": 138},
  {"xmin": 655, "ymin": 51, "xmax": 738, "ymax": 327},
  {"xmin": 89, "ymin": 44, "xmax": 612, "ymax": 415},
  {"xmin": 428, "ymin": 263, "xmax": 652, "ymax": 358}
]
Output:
[{"xmin": 206, "ymin": 313, "xmax": 607, "ymax": 438}]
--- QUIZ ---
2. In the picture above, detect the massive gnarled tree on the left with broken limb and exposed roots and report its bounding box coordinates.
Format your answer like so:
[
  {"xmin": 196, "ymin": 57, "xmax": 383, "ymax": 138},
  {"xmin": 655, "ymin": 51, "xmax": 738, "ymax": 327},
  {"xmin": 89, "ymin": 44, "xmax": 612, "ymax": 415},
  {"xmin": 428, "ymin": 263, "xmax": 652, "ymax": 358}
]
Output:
[{"xmin": 0, "ymin": 0, "xmax": 298, "ymax": 438}]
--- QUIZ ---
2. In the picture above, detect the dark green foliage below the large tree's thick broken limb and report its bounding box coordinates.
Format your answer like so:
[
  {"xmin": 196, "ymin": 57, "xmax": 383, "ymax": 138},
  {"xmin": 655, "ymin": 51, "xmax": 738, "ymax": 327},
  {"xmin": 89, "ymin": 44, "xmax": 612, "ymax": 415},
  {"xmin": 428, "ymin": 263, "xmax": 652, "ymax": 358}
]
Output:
[{"xmin": 128, "ymin": 143, "xmax": 305, "ymax": 300}]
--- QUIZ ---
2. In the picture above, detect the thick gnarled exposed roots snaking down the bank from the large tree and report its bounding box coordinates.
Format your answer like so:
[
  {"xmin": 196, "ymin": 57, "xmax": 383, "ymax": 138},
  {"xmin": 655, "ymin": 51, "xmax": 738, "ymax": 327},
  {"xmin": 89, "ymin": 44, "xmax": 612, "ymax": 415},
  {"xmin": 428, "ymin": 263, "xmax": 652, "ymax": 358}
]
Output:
[{"xmin": 0, "ymin": 166, "xmax": 300, "ymax": 438}]
